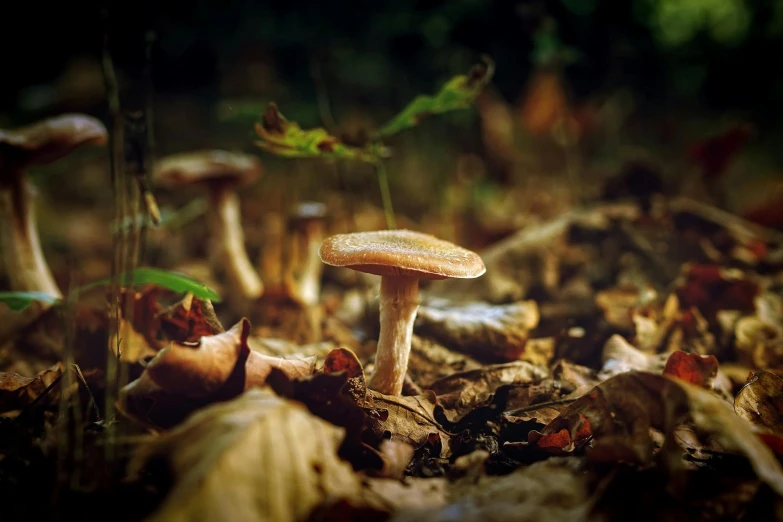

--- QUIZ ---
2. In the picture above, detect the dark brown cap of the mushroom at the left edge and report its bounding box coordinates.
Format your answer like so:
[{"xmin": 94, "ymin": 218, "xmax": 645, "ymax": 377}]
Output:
[{"xmin": 0, "ymin": 114, "xmax": 108, "ymax": 165}]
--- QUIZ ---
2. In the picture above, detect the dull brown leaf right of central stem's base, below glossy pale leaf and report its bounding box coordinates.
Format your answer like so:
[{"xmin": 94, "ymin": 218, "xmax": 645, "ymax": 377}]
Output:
[{"xmin": 430, "ymin": 361, "xmax": 549, "ymax": 423}]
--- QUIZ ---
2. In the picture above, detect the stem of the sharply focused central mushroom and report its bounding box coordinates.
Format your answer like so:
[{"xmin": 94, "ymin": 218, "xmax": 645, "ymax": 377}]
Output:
[{"xmin": 368, "ymin": 276, "xmax": 419, "ymax": 395}]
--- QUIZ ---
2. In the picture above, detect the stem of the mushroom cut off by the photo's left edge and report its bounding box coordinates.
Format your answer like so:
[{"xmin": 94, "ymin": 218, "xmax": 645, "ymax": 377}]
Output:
[{"xmin": 0, "ymin": 173, "xmax": 62, "ymax": 298}]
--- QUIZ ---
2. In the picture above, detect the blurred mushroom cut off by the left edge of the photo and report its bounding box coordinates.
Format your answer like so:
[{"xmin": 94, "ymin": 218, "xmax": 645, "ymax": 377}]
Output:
[{"xmin": 0, "ymin": 114, "xmax": 107, "ymax": 298}]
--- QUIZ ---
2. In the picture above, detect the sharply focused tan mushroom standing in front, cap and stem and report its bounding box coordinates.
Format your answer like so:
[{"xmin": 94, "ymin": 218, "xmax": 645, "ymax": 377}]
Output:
[{"xmin": 319, "ymin": 230, "xmax": 486, "ymax": 395}]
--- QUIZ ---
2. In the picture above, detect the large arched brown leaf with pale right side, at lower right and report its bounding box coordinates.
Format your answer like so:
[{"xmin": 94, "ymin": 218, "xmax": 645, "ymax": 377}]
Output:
[{"xmin": 529, "ymin": 371, "xmax": 783, "ymax": 494}]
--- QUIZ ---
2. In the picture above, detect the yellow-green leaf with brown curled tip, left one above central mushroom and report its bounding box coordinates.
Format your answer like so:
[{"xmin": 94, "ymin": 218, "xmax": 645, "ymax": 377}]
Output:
[{"xmin": 255, "ymin": 103, "xmax": 379, "ymax": 163}]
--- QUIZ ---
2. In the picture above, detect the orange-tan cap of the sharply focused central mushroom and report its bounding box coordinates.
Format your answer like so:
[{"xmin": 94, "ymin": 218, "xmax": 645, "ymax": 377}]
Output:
[{"xmin": 318, "ymin": 226, "xmax": 487, "ymax": 279}]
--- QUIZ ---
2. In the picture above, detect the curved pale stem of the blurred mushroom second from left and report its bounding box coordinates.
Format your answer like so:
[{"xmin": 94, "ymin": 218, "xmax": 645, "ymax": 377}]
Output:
[{"xmin": 209, "ymin": 189, "xmax": 264, "ymax": 300}]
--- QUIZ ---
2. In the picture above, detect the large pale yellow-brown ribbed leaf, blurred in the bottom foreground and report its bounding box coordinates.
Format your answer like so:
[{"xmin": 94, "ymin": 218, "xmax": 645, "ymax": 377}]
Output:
[{"xmin": 129, "ymin": 390, "xmax": 361, "ymax": 522}]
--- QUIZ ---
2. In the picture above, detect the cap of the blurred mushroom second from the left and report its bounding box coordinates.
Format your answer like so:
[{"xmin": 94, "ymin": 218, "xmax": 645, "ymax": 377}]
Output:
[{"xmin": 153, "ymin": 150, "xmax": 261, "ymax": 187}]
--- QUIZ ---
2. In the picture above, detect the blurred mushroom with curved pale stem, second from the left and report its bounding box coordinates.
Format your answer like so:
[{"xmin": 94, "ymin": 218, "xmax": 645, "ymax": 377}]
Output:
[{"xmin": 154, "ymin": 150, "xmax": 264, "ymax": 301}]
